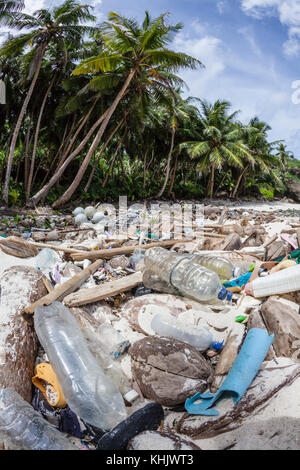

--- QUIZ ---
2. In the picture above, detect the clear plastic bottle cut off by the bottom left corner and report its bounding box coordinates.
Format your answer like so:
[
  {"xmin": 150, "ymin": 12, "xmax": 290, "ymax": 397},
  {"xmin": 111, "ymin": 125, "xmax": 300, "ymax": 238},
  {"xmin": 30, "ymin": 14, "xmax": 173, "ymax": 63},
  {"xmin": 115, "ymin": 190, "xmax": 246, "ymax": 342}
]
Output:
[{"xmin": 0, "ymin": 388, "xmax": 77, "ymax": 450}]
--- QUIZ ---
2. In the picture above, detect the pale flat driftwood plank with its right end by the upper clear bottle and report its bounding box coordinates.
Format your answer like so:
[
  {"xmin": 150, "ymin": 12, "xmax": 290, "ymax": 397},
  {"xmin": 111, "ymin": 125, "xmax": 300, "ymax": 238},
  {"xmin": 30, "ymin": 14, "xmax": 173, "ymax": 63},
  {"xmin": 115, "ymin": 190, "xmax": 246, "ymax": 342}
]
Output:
[{"xmin": 64, "ymin": 272, "xmax": 143, "ymax": 307}]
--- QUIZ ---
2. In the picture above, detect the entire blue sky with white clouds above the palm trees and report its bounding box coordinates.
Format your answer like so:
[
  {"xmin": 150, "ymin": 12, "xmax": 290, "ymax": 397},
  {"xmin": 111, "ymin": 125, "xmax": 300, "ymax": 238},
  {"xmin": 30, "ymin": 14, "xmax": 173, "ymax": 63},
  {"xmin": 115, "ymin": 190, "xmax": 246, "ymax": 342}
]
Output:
[{"xmin": 2, "ymin": 0, "xmax": 300, "ymax": 159}]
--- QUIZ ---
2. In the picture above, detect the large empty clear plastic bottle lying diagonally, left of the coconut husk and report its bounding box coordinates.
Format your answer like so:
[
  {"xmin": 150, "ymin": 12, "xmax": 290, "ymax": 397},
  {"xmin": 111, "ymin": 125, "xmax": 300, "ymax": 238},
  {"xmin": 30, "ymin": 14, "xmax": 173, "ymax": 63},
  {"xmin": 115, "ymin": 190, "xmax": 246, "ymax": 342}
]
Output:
[{"xmin": 34, "ymin": 302, "xmax": 126, "ymax": 430}]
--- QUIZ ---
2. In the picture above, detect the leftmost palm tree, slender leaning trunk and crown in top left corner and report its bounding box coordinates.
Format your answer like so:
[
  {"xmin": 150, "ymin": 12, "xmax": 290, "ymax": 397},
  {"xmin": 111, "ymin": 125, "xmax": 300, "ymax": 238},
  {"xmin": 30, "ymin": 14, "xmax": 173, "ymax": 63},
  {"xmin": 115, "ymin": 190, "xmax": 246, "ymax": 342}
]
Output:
[{"xmin": 0, "ymin": 0, "xmax": 95, "ymax": 204}]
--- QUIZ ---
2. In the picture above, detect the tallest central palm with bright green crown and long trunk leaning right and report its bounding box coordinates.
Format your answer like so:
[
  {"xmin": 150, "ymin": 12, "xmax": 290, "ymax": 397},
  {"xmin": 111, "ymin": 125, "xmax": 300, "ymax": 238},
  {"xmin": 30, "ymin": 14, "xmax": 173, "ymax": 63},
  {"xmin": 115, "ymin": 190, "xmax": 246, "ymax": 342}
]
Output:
[{"xmin": 53, "ymin": 12, "xmax": 201, "ymax": 207}]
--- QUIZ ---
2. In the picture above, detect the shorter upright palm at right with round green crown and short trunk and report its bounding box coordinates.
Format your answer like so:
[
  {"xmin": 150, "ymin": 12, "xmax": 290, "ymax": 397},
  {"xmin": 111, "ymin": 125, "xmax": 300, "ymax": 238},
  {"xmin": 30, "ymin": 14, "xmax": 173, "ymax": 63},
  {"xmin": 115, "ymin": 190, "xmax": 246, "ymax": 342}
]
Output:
[{"xmin": 180, "ymin": 100, "xmax": 251, "ymax": 198}]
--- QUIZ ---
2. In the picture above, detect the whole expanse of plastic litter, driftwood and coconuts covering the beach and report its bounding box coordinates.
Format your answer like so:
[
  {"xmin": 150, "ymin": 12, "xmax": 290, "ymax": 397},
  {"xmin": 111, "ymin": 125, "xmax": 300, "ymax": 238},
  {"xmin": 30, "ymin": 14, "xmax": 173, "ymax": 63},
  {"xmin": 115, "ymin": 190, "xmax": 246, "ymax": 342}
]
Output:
[{"xmin": 0, "ymin": 203, "xmax": 300, "ymax": 450}]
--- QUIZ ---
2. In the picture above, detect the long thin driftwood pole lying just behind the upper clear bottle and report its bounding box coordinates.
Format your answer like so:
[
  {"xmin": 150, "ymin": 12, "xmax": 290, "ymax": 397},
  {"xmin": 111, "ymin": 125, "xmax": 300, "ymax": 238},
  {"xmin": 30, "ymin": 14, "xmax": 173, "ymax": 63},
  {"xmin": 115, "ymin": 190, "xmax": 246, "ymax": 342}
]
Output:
[{"xmin": 71, "ymin": 240, "xmax": 185, "ymax": 261}]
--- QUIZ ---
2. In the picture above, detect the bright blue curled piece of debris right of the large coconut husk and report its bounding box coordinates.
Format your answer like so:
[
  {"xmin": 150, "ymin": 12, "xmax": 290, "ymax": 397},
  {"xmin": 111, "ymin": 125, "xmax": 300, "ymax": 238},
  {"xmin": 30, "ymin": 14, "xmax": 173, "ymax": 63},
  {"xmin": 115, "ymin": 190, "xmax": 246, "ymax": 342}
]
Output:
[{"xmin": 185, "ymin": 328, "xmax": 275, "ymax": 416}]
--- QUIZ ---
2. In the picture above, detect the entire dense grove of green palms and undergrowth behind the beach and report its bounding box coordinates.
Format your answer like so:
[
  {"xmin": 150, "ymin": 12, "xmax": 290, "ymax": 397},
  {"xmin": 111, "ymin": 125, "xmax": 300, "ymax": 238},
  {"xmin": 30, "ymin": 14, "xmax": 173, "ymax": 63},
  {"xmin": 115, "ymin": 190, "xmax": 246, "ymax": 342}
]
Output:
[{"xmin": 0, "ymin": 0, "xmax": 293, "ymax": 208}]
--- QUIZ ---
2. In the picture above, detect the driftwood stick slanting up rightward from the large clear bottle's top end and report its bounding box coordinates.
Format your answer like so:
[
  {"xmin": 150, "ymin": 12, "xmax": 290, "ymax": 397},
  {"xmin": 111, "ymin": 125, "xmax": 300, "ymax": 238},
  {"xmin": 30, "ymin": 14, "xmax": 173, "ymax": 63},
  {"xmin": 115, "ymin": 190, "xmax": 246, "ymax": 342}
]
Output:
[{"xmin": 22, "ymin": 259, "xmax": 103, "ymax": 316}]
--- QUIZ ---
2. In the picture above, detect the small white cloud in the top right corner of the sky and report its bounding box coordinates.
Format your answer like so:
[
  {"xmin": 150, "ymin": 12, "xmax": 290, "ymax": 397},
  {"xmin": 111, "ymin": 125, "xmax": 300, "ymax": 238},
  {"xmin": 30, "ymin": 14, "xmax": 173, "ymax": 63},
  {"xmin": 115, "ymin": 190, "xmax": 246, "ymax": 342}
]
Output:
[{"xmin": 241, "ymin": 0, "xmax": 300, "ymax": 57}]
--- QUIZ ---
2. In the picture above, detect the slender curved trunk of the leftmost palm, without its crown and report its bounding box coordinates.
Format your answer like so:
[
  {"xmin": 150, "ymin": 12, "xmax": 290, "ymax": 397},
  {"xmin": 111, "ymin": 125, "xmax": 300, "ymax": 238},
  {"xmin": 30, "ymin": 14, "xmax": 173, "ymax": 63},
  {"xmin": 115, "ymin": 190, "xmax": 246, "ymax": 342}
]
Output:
[{"xmin": 3, "ymin": 43, "xmax": 47, "ymax": 205}]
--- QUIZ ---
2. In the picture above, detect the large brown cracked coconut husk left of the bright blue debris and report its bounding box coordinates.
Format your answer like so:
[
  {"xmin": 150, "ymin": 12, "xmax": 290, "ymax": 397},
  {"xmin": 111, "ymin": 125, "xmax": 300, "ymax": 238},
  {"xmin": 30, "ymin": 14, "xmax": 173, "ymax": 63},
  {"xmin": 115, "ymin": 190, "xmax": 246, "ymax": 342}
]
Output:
[{"xmin": 129, "ymin": 336, "xmax": 213, "ymax": 406}]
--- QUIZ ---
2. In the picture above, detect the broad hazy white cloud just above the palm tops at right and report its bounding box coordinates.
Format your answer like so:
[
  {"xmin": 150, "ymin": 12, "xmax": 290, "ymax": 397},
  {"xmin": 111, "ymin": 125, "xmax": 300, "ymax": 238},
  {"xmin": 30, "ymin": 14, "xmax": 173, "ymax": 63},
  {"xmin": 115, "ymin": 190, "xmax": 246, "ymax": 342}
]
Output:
[{"xmin": 171, "ymin": 25, "xmax": 300, "ymax": 157}]
